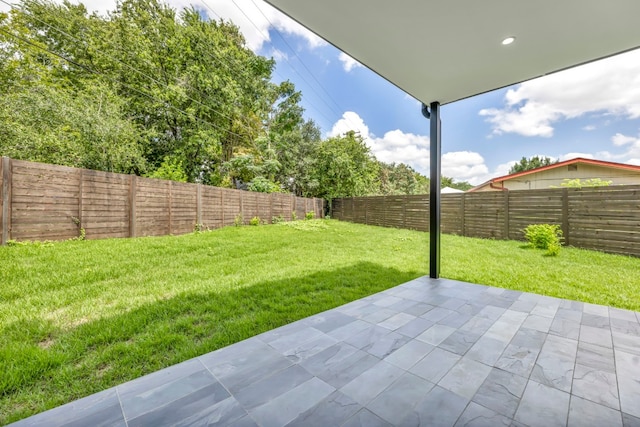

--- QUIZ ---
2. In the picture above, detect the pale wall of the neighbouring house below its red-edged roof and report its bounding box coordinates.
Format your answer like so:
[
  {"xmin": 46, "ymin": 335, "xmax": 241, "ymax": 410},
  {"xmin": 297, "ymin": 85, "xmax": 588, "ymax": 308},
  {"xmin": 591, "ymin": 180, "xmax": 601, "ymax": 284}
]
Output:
[{"xmin": 476, "ymin": 164, "xmax": 640, "ymax": 191}]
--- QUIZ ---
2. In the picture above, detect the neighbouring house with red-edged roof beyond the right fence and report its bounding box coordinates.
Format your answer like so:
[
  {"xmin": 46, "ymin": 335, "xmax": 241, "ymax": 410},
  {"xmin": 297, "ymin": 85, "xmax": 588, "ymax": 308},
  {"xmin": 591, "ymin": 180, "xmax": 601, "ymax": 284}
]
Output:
[{"xmin": 469, "ymin": 157, "xmax": 640, "ymax": 192}]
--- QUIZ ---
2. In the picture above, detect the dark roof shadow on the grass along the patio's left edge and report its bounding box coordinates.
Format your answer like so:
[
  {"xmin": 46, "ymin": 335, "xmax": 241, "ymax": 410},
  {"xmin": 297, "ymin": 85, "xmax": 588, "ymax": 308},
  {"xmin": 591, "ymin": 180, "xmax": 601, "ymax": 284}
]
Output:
[{"xmin": 0, "ymin": 262, "xmax": 420, "ymax": 424}]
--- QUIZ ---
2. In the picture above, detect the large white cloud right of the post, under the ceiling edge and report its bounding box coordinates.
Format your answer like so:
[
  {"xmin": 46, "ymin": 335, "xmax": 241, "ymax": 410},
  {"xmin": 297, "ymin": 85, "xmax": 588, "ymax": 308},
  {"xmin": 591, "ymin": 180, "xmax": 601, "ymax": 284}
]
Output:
[{"xmin": 480, "ymin": 49, "xmax": 640, "ymax": 137}]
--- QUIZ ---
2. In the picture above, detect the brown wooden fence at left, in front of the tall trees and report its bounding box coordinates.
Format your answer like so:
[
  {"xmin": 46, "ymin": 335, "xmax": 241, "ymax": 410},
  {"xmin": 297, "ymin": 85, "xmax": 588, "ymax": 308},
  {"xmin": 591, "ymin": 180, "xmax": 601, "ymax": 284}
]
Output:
[{"xmin": 0, "ymin": 157, "xmax": 324, "ymax": 244}]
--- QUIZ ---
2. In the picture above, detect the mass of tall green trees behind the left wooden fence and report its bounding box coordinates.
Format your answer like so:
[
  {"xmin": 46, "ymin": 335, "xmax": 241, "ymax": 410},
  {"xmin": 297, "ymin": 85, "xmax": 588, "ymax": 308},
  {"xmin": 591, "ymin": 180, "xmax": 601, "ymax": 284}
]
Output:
[{"xmin": 0, "ymin": 0, "xmax": 470, "ymax": 198}]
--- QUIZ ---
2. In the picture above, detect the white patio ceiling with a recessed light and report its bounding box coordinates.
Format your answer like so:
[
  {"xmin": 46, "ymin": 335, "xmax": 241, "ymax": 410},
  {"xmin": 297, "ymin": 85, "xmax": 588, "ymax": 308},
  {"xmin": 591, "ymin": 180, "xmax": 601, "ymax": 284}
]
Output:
[{"xmin": 267, "ymin": 0, "xmax": 640, "ymax": 104}]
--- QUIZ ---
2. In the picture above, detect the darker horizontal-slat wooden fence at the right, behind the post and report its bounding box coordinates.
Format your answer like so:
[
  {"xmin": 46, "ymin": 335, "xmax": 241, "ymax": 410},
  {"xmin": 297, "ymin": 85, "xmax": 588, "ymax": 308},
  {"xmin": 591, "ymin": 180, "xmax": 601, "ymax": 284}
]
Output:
[{"xmin": 331, "ymin": 185, "xmax": 640, "ymax": 256}]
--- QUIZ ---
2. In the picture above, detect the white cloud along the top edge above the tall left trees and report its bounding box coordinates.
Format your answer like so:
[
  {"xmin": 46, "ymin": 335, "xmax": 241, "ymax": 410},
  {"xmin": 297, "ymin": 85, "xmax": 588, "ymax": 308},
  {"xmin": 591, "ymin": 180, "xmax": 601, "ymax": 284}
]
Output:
[{"xmin": 0, "ymin": 0, "xmax": 326, "ymax": 52}]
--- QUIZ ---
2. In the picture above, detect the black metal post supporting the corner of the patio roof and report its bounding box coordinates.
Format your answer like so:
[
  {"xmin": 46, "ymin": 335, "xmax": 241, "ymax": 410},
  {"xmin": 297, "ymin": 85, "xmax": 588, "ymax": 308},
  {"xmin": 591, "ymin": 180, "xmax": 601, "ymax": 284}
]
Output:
[{"xmin": 422, "ymin": 102, "xmax": 442, "ymax": 279}]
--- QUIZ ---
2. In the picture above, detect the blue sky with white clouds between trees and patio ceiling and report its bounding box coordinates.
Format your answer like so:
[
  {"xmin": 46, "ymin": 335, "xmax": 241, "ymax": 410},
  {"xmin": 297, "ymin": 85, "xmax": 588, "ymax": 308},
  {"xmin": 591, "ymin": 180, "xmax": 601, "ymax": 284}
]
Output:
[{"xmin": 5, "ymin": 0, "xmax": 640, "ymax": 184}]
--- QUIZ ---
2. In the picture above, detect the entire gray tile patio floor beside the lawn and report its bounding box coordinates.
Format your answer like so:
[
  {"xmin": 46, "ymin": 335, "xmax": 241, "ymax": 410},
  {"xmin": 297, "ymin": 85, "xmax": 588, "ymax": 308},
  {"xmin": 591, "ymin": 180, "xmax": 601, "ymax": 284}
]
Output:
[{"xmin": 8, "ymin": 278, "xmax": 640, "ymax": 427}]
